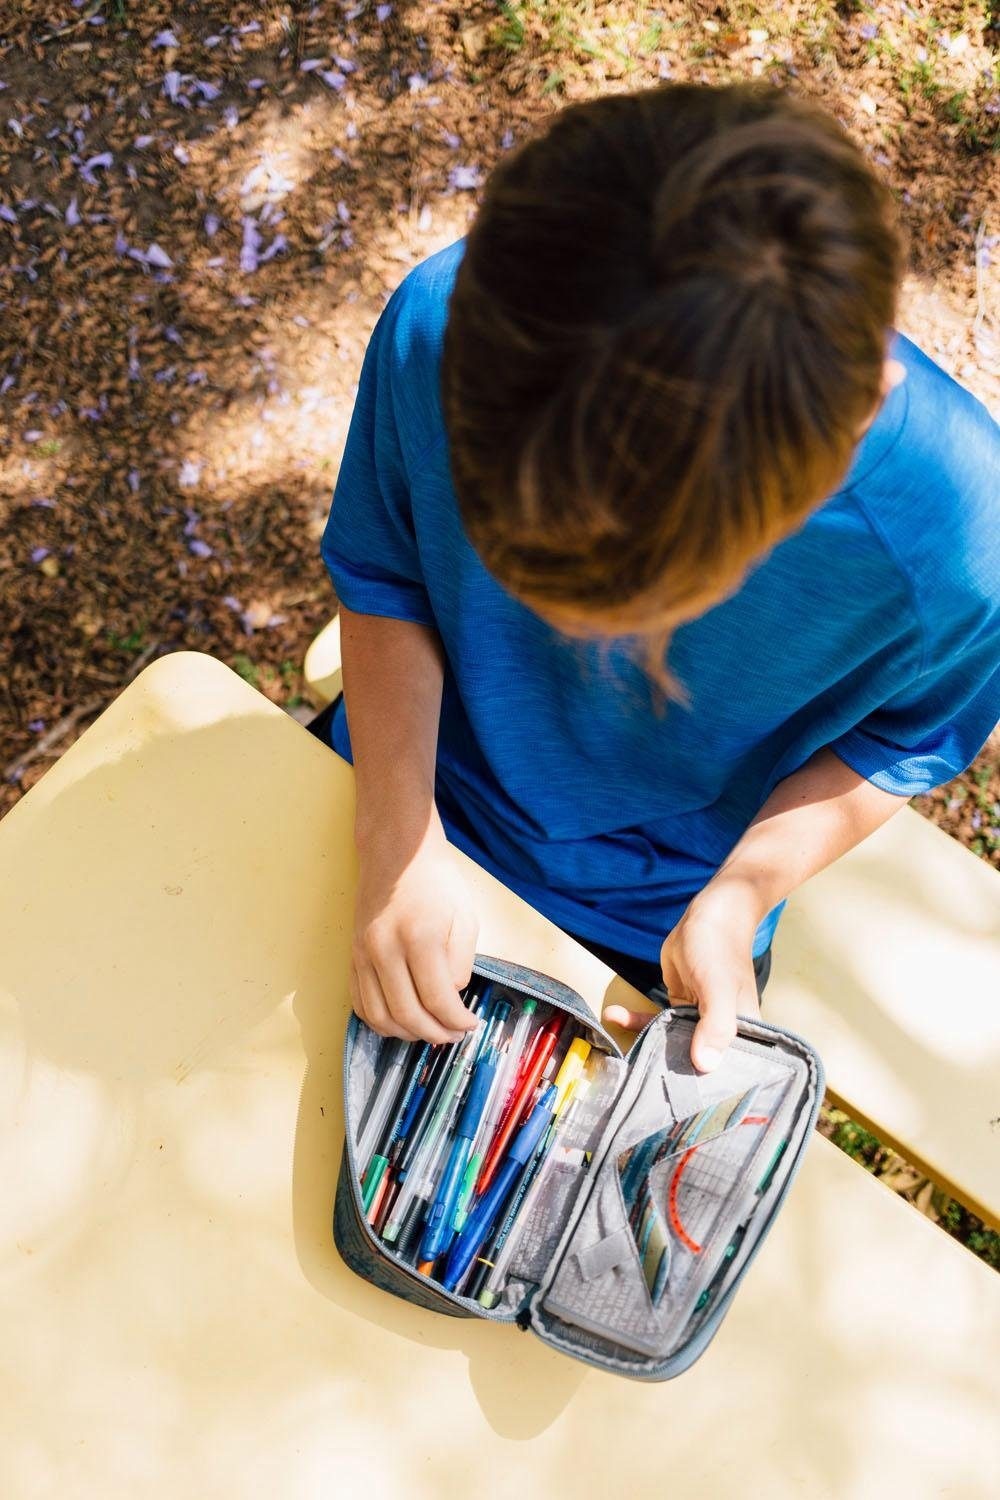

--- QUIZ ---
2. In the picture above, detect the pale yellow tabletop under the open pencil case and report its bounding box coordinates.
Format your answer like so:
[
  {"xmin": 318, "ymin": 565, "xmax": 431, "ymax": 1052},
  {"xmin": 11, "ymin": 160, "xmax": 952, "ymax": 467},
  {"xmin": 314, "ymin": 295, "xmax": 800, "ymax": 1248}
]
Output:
[{"xmin": 0, "ymin": 654, "xmax": 1000, "ymax": 1500}]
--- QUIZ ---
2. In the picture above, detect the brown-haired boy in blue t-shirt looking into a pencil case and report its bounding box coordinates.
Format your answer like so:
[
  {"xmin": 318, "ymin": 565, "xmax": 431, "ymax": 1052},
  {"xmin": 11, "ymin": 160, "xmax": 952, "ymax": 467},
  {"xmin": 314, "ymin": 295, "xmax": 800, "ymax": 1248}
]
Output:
[{"xmin": 324, "ymin": 84, "xmax": 1000, "ymax": 1071}]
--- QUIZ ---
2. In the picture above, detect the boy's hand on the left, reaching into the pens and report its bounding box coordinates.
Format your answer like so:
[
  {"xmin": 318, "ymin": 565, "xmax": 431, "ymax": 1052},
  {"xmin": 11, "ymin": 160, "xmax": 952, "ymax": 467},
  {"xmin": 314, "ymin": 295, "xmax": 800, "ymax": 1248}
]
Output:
[{"xmin": 351, "ymin": 812, "xmax": 478, "ymax": 1043}]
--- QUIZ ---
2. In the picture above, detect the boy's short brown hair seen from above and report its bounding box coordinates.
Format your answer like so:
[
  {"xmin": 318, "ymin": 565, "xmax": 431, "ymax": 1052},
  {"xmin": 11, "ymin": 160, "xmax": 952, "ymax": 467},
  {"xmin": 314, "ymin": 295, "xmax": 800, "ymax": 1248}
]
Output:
[{"xmin": 442, "ymin": 83, "xmax": 903, "ymax": 660}]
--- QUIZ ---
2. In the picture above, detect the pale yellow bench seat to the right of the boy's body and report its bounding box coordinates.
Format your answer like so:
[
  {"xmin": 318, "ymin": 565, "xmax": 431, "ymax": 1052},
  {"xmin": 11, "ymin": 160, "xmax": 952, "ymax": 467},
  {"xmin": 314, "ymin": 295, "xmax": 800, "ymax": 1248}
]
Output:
[{"xmin": 766, "ymin": 809, "xmax": 1000, "ymax": 1229}]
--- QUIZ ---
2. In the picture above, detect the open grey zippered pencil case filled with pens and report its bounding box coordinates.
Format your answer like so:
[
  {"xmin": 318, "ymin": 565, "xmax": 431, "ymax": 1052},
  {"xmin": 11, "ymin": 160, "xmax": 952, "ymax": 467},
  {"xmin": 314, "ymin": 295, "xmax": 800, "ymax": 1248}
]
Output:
[{"xmin": 333, "ymin": 956, "xmax": 823, "ymax": 1380}]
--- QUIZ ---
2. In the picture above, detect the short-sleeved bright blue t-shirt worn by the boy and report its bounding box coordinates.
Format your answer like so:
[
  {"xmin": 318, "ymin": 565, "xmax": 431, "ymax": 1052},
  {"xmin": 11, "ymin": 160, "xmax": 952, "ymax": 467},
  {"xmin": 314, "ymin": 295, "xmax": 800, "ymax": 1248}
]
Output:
[{"xmin": 322, "ymin": 242, "xmax": 1000, "ymax": 960}]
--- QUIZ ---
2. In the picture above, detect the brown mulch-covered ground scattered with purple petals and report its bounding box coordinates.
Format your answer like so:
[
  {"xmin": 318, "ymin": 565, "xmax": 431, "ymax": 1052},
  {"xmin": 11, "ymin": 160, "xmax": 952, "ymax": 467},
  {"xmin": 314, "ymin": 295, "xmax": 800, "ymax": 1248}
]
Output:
[{"xmin": 0, "ymin": 0, "xmax": 1000, "ymax": 1260}]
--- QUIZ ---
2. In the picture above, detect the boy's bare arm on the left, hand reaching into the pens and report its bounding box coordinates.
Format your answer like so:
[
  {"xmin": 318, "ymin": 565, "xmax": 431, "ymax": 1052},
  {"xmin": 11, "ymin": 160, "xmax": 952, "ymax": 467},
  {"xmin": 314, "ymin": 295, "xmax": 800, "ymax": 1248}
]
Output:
[{"xmin": 340, "ymin": 605, "xmax": 478, "ymax": 1043}]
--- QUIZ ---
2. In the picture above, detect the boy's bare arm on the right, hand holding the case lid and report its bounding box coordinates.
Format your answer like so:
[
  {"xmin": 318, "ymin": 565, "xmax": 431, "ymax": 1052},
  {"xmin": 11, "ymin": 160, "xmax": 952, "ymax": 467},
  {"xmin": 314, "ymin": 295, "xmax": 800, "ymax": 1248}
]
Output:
[{"xmin": 606, "ymin": 750, "xmax": 907, "ymax": 1073}]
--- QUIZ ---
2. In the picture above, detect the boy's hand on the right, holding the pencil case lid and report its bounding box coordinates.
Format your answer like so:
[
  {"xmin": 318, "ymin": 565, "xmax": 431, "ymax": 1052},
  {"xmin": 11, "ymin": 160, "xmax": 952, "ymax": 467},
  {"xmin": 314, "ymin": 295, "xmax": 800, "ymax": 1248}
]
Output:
[{"xmin": 604, "ymin": 876, "xmax": 760, "ymax": 1073}]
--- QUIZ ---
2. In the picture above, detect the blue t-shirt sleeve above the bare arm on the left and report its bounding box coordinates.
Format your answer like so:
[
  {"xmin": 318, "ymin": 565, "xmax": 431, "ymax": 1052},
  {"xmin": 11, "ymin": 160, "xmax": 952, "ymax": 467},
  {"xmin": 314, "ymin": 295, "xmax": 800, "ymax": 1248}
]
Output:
[{"xmin": 321, "ymin": 288, "xmax": 435, "ymax": 626}]
